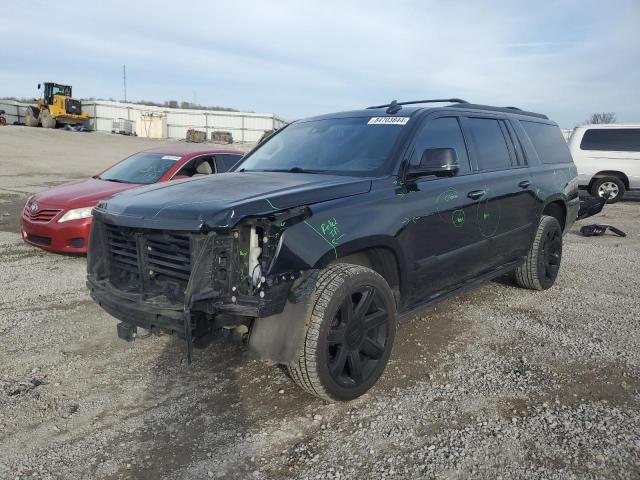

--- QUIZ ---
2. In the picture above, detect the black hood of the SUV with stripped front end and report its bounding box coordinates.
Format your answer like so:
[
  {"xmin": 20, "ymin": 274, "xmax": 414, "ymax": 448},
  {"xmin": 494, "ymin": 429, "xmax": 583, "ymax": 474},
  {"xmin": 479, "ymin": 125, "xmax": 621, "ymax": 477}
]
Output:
[{"xmin": 94, "ymin": 172, "xmax": 371, "ymax": 231}]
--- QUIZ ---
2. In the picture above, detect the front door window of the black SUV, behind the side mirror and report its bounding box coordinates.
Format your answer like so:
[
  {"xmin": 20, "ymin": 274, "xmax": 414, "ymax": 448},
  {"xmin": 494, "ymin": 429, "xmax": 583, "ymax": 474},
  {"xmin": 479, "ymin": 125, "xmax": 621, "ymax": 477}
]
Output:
[{"xmin": 411, "ymin": 117, "xmax": 471, "ymax": 174}]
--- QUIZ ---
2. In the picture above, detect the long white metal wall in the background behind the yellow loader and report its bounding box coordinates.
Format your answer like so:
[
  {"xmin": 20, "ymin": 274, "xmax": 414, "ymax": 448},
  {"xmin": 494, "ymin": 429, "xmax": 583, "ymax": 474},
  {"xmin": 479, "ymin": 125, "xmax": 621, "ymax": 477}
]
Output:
[{"xmin": 0, "ymin": 99, "xmax": 286, "ymax": 142}]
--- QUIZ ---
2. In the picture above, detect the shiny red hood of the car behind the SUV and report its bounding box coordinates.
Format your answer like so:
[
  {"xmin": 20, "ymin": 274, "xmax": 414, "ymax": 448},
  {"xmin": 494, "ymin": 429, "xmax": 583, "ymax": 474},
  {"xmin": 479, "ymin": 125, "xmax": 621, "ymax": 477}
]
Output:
[{"xmin": 33, "ymin": 178, "xmax": 140, "ymax": 208}]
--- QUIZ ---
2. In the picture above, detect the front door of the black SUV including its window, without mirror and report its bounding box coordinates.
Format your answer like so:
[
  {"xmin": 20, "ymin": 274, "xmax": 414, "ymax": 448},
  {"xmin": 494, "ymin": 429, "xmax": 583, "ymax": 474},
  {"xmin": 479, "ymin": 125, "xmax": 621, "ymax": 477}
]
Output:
[{"xmin": 398, "ymin": 116, "xmax": 492, "ymax": 305}]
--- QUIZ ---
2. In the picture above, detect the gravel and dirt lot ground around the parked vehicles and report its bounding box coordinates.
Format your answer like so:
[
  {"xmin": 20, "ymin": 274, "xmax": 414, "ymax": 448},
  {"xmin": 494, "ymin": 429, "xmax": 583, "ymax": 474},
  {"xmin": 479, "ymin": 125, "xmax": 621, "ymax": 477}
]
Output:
[{"xmin": 0, "ymin": 127, "xmax": 640, "ymax": 479}]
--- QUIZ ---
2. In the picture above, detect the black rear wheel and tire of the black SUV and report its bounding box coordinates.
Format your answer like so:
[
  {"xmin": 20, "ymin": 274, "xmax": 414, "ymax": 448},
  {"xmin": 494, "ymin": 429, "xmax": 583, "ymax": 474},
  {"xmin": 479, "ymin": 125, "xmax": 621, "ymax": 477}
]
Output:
[{"xmin": 515, "ymin": 215, "xmax": 562, "ymax": 290}]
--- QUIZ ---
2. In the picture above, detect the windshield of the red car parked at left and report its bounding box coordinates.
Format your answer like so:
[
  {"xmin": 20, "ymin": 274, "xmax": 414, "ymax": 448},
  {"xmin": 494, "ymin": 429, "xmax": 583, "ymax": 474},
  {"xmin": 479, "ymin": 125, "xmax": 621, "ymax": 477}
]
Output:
[{"xmin": 96, "ymin": 152, "xmax": 181, "ymax": 184}]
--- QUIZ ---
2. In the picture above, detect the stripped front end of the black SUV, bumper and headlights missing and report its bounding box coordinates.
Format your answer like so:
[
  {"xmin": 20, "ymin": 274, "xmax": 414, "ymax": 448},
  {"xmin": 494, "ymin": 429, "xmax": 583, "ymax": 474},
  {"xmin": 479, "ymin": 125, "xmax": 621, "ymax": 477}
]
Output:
[{"xmin": 87, "ymin": 207, "xmax": 310, "ymax": 362}]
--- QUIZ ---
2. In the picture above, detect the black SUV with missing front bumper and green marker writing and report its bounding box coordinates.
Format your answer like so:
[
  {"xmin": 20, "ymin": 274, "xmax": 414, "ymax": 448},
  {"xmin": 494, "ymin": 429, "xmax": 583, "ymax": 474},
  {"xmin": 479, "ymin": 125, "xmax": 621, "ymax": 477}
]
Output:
[{"xmin": 88, "ymin": 99, "xmax": 579, "ymax": 401}]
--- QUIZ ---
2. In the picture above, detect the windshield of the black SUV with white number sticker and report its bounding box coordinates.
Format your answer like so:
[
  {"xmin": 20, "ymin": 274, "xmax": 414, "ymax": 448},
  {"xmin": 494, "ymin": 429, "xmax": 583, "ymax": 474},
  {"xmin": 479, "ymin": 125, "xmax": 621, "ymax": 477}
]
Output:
[{"xmin": 235, "ymin": 117, "xmax": 408, "ymax": 175}]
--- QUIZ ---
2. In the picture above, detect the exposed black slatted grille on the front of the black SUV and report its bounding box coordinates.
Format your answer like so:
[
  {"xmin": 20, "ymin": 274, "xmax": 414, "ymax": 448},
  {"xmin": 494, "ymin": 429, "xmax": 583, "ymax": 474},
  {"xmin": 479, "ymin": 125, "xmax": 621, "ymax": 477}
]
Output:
[{"xmin": 104, "ymin": 224, "xmax": 192, "ymax": 297}]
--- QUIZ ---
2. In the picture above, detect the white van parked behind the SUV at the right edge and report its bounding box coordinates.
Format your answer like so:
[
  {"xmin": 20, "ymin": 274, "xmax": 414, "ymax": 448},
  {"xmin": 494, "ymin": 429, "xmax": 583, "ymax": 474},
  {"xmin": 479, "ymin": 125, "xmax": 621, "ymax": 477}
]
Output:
[{"xmin": 569, "ymin": 123, "xmax": 640, "ymax": 203}]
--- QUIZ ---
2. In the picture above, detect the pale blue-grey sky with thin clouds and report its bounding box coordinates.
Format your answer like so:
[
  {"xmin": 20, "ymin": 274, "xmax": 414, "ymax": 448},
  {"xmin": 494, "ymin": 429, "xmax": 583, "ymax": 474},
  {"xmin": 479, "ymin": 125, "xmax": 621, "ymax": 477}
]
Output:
[{"xmin": 0, "ymin": 0, "xmax": 640, "ymax": 127}]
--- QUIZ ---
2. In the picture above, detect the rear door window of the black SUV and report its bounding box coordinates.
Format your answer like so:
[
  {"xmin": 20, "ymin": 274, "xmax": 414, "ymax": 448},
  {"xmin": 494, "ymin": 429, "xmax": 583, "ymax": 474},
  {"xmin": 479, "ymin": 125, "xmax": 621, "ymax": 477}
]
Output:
[{"xmin": 466, "ymin": 118, "xmax": 512, "ymax": 170}]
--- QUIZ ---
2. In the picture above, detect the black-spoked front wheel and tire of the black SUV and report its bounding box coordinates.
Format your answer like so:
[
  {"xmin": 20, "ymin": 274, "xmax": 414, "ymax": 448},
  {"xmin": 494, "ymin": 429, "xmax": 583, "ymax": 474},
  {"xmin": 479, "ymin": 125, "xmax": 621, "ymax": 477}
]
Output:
[{"xmin": 287, "ymin": 263, "xmax": 396, "ymax": 402}]
